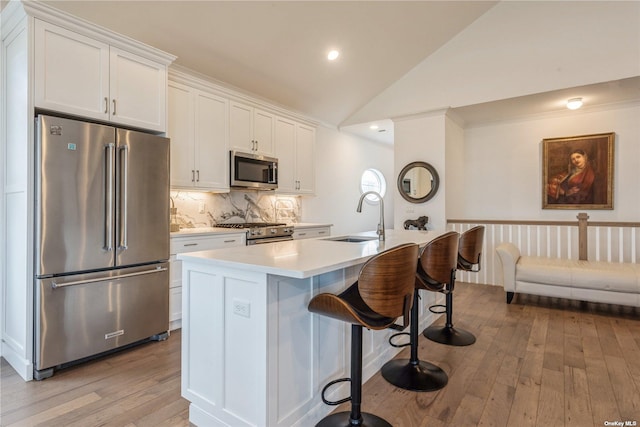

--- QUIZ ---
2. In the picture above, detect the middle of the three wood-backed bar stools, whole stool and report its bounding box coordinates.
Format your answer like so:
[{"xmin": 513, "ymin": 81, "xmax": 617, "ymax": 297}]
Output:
[{"xmin": 381, "ymin": 231, "xmax": 460, "ymax": 391}]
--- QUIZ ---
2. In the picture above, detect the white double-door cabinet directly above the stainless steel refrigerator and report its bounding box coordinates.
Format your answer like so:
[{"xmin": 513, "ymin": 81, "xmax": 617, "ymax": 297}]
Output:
[{"xmin": 35, "ymin": 19, "xmax": 167, "ymax": 132}]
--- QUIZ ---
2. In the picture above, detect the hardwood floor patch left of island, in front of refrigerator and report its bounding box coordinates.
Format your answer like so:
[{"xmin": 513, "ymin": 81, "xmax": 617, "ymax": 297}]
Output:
[{"xmin": 0, "ymin": 331, "xmax": 189, "ymax": 427}]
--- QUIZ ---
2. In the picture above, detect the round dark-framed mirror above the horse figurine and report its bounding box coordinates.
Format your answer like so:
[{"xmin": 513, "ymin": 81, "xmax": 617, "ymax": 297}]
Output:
[{"xmin": 398, "ymin": 162, "xmax": 440, "ymax": 203}]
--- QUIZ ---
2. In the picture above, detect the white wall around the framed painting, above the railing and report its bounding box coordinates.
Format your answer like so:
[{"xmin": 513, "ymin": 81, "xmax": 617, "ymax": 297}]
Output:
[{"xmin": 458, "ymin": 103, "xmax": 640, "ymax": 222}]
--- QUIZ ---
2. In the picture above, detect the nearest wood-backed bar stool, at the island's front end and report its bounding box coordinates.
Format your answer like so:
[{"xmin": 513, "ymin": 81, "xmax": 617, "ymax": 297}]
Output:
[{"xmin": 309, "ymin": 243, "xmax": 418, "ymax": 427}]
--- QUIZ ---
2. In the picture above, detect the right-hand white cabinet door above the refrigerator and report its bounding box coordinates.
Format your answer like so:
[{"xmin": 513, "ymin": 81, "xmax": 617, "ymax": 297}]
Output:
[{"xmin": 110, "ymin": 47, "xmax": 167, "ymax": 132}]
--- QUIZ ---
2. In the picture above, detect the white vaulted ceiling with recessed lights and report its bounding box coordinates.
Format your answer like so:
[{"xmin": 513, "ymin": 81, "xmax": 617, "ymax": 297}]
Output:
[{"xmin": 18, "ymin": 0, "xmax": 640, "ymax": 142}]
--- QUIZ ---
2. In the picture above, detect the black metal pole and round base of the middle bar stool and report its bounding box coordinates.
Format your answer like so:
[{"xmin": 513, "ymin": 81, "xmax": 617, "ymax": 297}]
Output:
[{"xmin": 381, "ymin": 289, "xmax": 449, "ymax": 391}]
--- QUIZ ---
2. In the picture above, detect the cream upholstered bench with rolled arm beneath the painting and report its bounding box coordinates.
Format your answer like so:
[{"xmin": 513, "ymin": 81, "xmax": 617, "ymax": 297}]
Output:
[{"xmin": 496, "ymin": 243, "xmax": 640, "ymax": 307}]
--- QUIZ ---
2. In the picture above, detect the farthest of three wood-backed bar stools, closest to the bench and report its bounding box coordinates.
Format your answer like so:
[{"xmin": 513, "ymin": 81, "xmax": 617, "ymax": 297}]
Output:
[{"xmin": 423, "ymin": 225, "xmax": 484, "ymax": 346}]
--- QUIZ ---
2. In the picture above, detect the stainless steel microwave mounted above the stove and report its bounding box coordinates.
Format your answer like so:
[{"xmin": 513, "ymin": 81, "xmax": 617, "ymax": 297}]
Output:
[{"xmin": 230, "ymin": 151, "xmax": 278, "ymax": 190}]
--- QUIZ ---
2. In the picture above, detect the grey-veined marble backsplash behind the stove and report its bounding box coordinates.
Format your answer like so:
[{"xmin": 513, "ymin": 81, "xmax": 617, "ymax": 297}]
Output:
[{"xmin": 170, "ymin": 190, "xmax": 301, "ymax": 228}]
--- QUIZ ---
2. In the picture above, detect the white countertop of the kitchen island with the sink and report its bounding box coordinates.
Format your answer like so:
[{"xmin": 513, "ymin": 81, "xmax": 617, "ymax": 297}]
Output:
[{"xmin": 178, "ymin": 230, "xmax": 445, "ymax": 279}]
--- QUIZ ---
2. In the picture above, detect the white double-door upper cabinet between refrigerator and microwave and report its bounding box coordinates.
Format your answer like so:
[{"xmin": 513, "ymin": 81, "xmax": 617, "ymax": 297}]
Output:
[{"xmin": 169, "ymin": 81, "xmax": 229, "ymax": 191}]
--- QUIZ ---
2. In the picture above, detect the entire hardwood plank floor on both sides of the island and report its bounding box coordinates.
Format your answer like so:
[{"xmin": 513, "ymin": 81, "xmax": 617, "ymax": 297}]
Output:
[{"xmin": 0, "ymin": 283, "xmax": 640, "ymax": 427}]
